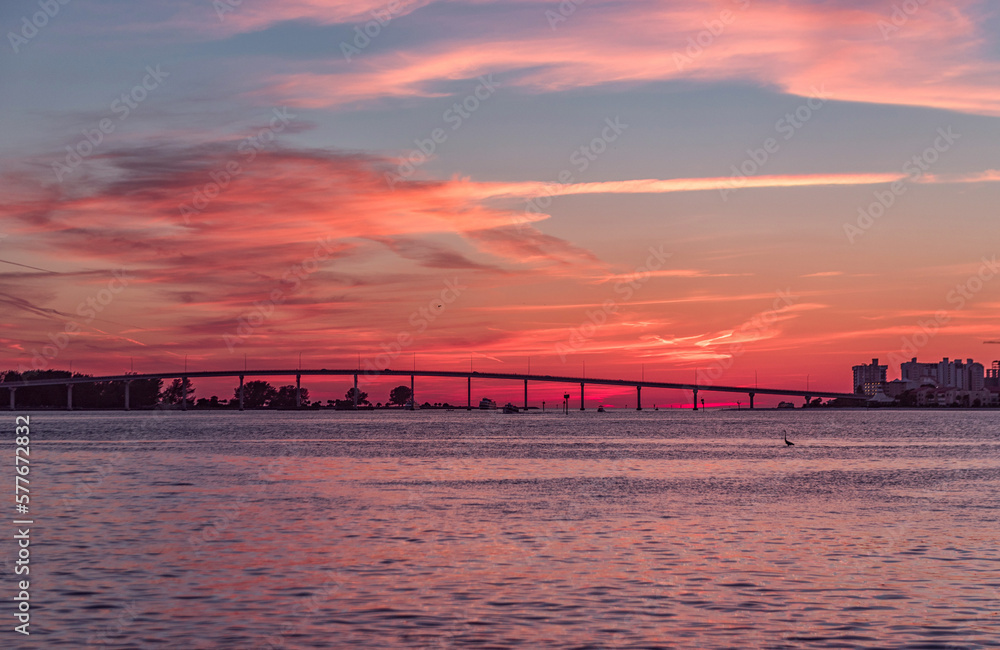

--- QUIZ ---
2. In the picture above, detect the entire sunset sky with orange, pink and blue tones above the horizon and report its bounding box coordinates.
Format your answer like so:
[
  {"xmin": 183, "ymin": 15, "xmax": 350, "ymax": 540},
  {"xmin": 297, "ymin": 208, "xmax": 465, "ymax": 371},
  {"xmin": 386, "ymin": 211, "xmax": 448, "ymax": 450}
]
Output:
[{"xmin": 0, "ymin": 0, "xmax": 1000, "ymax": 405}]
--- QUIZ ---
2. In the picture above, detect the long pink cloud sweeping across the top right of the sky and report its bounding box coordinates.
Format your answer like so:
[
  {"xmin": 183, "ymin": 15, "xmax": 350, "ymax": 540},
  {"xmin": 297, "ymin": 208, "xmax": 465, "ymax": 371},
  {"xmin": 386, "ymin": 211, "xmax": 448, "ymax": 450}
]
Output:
[{"xmin": 254, "ymin": 0, "xmax": 1000, "ymax": 115}]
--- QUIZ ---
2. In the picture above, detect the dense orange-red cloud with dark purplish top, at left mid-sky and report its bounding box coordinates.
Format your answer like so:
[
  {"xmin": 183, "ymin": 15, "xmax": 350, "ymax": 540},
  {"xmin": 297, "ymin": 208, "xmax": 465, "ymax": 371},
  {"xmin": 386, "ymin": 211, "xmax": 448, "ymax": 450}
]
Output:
[{"xmin": 4, "ymin": 145, "xmax": 594, "ymax": 271}]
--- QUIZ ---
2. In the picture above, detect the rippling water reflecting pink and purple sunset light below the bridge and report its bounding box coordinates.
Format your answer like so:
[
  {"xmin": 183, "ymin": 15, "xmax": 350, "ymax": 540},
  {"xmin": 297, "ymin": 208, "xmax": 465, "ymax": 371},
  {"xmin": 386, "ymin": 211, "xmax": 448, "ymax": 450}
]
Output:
[{"xmin": 9, "ymin": 411, "xmax": 1000, "ymax": 648}]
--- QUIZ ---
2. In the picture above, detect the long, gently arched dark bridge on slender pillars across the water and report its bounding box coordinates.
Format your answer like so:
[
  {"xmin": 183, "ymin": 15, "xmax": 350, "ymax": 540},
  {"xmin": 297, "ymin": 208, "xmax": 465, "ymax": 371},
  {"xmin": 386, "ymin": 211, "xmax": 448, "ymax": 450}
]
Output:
[{"xmin": 0, "ymin": 368, "xmax": 858, "ymax": 411}]
